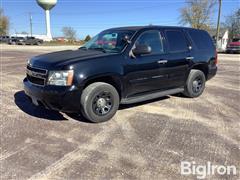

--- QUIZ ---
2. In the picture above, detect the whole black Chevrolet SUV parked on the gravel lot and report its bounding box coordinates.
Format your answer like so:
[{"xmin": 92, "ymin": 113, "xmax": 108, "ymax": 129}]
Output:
[{"xmin": 23, "ymin": 26, "xmax": 217, "ymax": 122}]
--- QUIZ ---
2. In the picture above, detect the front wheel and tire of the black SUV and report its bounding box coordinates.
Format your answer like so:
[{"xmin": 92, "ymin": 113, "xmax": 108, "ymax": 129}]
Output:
[{"xmin": 81, "ymin": 82, "xmax": 119, "ymax": 123}]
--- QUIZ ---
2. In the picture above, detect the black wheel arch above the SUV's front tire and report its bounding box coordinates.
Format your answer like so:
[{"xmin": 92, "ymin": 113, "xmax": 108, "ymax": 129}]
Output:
[{"xmin": 83, "ymin": 76, "xmax": 122, "ymax": 99}]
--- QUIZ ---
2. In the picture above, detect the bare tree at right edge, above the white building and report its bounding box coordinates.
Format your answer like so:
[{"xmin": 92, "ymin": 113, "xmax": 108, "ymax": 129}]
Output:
[{"xmin": 223, "ymin": 8, "xmax": 240, "ymax": 39}]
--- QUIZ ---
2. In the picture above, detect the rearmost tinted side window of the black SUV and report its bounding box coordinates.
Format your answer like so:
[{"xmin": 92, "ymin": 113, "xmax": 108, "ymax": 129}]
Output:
[{"xmin": 188, "ymin": 29, "xmax": 213, "ymax": 50}]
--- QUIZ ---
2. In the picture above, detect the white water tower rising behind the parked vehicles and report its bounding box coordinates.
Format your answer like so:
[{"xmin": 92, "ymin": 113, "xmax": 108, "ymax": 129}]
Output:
[{"xmin": 37, "ymin": 0, "xmax": 57, "ymax": 40}]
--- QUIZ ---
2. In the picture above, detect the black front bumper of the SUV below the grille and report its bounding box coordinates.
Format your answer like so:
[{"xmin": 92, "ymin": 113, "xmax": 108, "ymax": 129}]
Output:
[{"xmin": 23, "ymin": 78, "xmax": 82, "ymax": 113}]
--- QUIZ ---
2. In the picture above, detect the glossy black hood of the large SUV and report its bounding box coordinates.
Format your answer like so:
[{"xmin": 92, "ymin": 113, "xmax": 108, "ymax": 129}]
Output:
[{"xmin": 30, "ymin": 49, "xmax": 106, "ymax": 69}]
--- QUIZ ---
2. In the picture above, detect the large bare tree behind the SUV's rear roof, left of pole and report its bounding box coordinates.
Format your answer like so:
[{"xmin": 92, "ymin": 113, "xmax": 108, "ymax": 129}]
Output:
[{"xmin": 180, "ymin": 0, "xmax": 216, "ymax": 30}]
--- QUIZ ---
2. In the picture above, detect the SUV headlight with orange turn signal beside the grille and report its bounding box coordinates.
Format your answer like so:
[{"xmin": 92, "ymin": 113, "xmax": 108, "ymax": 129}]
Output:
[{"xmin": 47, "ymin": 70, "xmax": 73, "ymax": 86}]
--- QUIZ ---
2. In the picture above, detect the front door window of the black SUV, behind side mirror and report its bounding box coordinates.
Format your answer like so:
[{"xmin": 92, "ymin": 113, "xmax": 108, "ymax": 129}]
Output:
[{"xmin": 135, "ymin": 31, "xmax": 163, "ymax": 54}]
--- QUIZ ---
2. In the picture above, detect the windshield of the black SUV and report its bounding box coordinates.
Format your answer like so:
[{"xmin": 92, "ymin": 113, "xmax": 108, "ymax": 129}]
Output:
[{"xmin": 81, "ymin": 30, "xmax": 135, "ymax": 53}]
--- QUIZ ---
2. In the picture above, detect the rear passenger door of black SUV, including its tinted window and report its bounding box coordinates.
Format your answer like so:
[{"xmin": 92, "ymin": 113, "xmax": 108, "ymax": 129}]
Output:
[{"xmin": 164, "ymin": 29, "xmax": 193, "ymax": 88}]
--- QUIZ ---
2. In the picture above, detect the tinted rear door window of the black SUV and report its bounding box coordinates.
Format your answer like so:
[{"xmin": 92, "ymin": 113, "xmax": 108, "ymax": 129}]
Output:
[{"xmin": 166, "ymin": 30, "xmax": 188, "ymax": 52}]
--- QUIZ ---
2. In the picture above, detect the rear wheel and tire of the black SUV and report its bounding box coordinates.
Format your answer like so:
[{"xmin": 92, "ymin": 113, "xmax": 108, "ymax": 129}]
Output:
[{"xmin": 183, "ymin": 69, "xmax": 206, "ymax": 98}]
